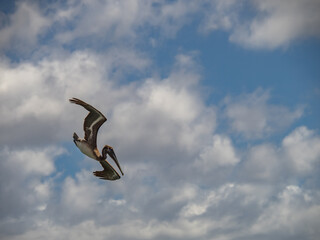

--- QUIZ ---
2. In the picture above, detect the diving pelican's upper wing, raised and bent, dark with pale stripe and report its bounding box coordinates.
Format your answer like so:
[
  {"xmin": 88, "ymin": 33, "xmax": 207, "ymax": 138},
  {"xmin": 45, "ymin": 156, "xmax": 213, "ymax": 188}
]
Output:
[{"xmin": 69, "ymin": 98, "xmax": 107, "ymax": 148}]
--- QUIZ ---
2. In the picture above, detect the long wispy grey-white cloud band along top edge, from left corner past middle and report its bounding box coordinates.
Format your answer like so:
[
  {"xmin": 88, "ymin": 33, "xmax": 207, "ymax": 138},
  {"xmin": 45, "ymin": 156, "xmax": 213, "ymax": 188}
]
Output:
[{"xmin": 0, "ymin": 0, "xmax": 199, "ymax": 54}]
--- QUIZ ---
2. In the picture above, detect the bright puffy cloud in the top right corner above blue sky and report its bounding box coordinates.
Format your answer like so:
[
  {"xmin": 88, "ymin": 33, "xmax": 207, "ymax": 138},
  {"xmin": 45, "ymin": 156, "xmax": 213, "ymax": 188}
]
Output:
[{"xmin": 200, "ymin": 0, "xmax": 320, "ymax": 49}]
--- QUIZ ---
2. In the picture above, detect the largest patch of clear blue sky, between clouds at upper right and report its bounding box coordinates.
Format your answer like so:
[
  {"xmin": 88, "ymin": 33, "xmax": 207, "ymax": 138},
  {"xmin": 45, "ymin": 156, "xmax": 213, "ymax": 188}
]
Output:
[{"xmin": 142, "ymin": 18, "xmax": 320, "ymax": 107}]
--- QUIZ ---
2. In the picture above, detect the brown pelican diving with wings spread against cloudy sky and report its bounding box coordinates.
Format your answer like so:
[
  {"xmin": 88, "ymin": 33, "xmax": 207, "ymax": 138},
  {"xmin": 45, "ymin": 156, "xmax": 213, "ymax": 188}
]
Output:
[{"xmin": 69, "ymin": 98, "xmax": 123, "ymax": 180}]
